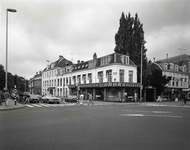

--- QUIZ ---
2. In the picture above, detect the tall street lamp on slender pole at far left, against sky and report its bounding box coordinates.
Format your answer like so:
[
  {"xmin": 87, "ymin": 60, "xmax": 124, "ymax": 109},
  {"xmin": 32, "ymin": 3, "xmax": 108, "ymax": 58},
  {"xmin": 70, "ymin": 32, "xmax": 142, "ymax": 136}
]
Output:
[{"xmin": 5, "ymin": 8, "xmax": 17, "ymax": 90}]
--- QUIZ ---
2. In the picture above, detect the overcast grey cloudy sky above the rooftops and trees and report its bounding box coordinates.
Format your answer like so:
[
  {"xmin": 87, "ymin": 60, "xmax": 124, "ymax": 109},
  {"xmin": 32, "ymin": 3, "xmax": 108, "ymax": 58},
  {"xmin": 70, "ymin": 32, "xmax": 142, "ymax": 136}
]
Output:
[{"xmin": 0, "ymin": 0, "xmax": 190, "ymax": 79}]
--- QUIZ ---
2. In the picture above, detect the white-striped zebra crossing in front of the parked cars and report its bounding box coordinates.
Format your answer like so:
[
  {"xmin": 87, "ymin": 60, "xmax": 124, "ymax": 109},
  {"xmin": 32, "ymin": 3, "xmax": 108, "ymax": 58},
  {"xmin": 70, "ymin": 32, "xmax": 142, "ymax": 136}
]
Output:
[{"xmin": 25, "ymin": 103, "xmax": 76, "ymax": 108}]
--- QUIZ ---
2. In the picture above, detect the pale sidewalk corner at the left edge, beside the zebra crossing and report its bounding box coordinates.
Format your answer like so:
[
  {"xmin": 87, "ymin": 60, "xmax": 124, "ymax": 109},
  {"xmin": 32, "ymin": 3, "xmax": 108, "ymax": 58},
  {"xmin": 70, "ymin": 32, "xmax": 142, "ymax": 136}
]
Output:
[{"xmin": 0, "ymin": 99, "xmax": 25, "ymax": 111}]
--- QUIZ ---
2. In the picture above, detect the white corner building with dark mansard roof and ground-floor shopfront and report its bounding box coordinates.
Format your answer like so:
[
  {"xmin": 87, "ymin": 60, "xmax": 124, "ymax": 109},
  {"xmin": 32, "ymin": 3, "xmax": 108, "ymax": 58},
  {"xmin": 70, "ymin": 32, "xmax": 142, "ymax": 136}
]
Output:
[{"xmin": 42, "ymin": 53, "xmax": 140, "ymax": 101}]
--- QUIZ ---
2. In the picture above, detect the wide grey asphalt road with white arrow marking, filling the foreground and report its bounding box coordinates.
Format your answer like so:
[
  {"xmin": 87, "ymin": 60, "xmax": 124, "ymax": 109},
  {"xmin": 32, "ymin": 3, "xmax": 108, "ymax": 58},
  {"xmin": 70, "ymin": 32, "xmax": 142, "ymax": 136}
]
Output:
[{"xmin": 0, "ymin": 104, "xmax": 190, "ymax": 150}]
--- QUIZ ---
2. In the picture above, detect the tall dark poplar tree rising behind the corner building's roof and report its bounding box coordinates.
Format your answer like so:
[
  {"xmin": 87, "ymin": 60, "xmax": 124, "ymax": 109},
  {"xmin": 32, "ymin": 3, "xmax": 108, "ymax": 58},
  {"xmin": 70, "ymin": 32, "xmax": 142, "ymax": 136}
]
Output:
[{"xmin": 114, "ymin": 12, "xmax": 147, "ymax": 81}]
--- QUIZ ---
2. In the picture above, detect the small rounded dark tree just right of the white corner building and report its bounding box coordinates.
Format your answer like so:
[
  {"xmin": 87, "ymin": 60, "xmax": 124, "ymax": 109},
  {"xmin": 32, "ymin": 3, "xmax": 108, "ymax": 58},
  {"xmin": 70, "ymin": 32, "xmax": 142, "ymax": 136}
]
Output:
[{"xmin": 147, "ymin": 69, "xmax": 171, "ymax": 96}]
